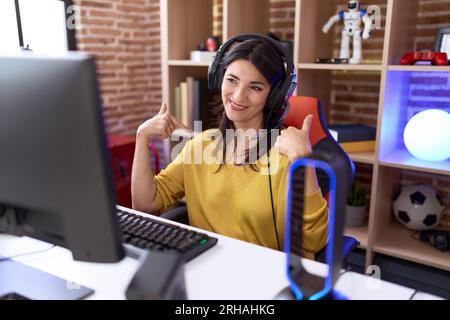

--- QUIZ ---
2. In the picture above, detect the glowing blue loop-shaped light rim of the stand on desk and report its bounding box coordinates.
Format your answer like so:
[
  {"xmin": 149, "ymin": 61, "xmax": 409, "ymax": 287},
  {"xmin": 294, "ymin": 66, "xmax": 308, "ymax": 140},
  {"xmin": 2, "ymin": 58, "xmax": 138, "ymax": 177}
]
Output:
[{"xmin": 284, "ymin": 158, "xmax": 336, "ymax": 300}]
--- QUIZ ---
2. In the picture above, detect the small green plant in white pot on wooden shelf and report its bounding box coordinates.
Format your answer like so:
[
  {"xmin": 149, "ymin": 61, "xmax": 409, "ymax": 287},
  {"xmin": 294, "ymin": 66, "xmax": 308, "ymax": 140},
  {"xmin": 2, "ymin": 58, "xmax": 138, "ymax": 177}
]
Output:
[{"xmin": 345, "ymin": 183, "xmax": 367, "ymax": 227}]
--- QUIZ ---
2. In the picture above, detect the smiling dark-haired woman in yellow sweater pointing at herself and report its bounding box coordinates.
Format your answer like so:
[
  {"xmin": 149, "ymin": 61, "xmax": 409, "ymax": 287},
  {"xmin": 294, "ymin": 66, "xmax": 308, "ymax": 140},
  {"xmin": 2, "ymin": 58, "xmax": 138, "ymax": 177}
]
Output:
[{"xmin": 132, "ymin": 38, "xmax": 328, "ymax": 259}]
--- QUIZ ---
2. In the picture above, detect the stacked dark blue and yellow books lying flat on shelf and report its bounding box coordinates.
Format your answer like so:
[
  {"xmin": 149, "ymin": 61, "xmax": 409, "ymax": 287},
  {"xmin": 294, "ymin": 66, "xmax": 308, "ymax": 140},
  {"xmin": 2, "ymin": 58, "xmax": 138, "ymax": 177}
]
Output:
[{"xmin": 328, "ymin": 124, "xmax": 377, "ymax": 153}]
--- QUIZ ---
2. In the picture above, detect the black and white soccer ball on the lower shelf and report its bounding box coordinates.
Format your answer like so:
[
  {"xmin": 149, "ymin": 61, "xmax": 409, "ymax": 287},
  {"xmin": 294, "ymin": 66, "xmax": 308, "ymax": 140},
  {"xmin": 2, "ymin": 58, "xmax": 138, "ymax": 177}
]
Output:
[{"xmin": 393, "ymin": 184, "xmax": 444, "ymax": 231}]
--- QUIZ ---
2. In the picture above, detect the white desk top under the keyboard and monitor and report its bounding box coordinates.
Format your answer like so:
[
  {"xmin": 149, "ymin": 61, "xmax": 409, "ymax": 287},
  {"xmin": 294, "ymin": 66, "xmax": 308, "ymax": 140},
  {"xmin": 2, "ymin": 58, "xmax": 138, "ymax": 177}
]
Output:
[{"xmin": 0, "ymin": 208, "xmax": 442, "ymax": 300}]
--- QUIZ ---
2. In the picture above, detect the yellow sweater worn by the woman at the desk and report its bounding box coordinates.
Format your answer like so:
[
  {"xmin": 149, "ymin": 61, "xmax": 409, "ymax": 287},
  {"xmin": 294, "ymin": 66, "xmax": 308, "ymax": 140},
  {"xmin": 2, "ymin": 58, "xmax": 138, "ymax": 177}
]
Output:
[{"xmin": 155, "ymin": 130, "xmax": 328, "ymax": 259}]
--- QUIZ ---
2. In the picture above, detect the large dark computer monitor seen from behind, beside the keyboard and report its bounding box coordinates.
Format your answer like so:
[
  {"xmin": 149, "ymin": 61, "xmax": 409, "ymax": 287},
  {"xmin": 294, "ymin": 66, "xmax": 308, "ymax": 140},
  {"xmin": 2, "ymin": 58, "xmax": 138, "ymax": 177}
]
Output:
[{"xmin": 0, "ymin": 52, "xmax": 124, "ymax": 262}]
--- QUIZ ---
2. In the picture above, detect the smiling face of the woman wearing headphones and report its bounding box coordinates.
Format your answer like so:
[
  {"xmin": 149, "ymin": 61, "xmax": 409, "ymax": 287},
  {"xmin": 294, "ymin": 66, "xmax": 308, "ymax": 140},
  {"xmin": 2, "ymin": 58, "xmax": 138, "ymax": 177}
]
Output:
[{"xmin": 222, "ymin": 59, "xmax": 271, "ymax": 130}]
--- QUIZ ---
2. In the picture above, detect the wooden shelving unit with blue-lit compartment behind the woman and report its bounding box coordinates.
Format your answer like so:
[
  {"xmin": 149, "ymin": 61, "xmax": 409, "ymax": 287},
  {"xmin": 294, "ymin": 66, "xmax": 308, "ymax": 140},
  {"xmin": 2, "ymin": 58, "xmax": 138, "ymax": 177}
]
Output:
[{"xmin": 160, "ymin": 0, "xmax": 450, "ymax": 271}]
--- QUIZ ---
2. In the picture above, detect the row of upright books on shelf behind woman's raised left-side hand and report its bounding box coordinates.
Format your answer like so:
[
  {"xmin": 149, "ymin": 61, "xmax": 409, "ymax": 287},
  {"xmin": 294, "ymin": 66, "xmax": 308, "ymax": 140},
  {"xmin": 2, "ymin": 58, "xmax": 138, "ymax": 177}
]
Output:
[{"xmin": 171, "ymin": 77, "xmax": 212, "ymax": 131}]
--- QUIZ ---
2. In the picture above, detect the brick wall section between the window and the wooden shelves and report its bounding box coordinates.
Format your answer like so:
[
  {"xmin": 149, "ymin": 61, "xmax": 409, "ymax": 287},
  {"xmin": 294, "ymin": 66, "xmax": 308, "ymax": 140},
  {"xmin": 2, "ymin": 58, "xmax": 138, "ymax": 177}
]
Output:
[{"xmin": 74, "ymin": 0, "xmax": 161, "ymax": 135}]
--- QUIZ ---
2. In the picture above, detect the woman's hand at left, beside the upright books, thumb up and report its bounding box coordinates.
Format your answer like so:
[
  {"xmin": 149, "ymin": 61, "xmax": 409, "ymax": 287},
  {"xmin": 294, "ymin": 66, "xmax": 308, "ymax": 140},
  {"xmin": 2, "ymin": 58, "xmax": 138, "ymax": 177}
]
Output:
[{"xmin": 137, "ymin": 102, "xmax": 192, "ymax": 139}]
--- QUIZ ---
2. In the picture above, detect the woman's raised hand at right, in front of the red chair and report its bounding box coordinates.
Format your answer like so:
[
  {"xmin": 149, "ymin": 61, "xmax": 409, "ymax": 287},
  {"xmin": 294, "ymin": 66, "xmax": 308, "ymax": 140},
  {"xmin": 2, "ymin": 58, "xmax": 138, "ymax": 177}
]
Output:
[{"xmin": 275, "ymin": 114, "xmax": 313, "ymax": 162}]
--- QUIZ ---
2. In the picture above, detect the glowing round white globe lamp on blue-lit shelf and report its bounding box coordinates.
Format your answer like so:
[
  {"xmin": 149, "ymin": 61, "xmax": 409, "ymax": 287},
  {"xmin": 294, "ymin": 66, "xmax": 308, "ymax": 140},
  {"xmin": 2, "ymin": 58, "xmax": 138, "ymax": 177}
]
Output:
[{"xmin": 403, "ymin": 109, "xmax": 450, "ymax": 161}]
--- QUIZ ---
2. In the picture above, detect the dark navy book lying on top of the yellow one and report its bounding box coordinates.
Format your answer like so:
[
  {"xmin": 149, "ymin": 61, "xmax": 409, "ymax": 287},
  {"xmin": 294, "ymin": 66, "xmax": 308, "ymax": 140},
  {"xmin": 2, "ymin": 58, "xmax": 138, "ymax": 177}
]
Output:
[{"xmin": 328, "ymin": 124, "xmax": 377, "ymax": 143}]
